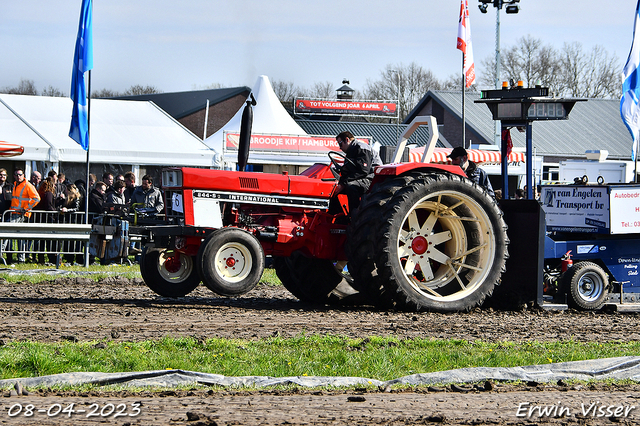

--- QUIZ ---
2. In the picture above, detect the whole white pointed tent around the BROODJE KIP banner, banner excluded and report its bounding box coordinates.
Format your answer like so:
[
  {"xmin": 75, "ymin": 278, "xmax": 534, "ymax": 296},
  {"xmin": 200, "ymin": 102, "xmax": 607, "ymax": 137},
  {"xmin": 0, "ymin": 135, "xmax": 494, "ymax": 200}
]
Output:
[{"xmin": 204, "ymin": 75, "xmax": 318, "ymax": 168}]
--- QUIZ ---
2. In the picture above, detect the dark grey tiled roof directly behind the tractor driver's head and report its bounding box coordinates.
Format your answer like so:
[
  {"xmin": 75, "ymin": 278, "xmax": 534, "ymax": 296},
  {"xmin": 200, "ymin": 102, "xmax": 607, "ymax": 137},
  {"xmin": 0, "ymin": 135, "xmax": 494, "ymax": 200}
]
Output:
[{"xmin": 296, "ymin": 118, "xmax": 444, "ymax": 147}]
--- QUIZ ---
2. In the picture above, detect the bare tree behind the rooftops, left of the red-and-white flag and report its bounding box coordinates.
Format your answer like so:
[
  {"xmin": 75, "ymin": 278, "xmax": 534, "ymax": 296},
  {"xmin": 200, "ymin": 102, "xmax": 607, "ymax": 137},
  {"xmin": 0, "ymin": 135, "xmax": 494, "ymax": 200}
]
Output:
[{"xmin": 365, "ymin": 62, "xmax": 444, "ymax": 120}]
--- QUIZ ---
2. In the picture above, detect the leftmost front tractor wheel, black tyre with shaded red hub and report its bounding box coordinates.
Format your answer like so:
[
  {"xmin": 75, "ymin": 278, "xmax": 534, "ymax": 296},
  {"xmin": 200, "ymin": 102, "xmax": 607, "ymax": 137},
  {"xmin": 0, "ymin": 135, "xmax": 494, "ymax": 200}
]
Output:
[{"xmin": 140, "ymin": 247, "xmax": 200, "ymax": 297}]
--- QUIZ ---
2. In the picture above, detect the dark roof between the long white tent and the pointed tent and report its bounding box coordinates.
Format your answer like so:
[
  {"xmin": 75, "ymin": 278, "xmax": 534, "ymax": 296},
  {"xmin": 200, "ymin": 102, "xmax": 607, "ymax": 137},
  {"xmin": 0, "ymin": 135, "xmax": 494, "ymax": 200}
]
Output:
[{"xmin": 112, "ymin": 86, "xmax": 251, "ymax": 120}]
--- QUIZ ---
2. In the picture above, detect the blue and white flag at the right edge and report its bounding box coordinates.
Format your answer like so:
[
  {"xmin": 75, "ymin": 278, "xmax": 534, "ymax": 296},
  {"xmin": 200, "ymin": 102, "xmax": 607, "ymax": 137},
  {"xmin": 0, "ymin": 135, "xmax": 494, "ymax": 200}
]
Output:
[{"xmin": 620, "ymin": 0, "xmax": 640, "ymax": 161}]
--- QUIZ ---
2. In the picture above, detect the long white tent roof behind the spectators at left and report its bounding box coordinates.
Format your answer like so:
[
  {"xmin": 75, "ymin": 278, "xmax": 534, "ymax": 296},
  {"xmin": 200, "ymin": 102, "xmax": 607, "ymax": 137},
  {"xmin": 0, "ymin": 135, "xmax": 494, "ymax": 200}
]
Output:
[{"xmin": 0, "ymin": 94, "xmax": 215, "ymax": 167}]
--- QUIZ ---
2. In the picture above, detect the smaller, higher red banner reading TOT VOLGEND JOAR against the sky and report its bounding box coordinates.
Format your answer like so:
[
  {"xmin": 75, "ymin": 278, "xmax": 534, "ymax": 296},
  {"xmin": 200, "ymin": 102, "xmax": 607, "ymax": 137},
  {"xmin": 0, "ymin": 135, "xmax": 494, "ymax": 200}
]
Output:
[{"xmin": 293, "ymin": 98, "xmax": 398, "ymax": 117}]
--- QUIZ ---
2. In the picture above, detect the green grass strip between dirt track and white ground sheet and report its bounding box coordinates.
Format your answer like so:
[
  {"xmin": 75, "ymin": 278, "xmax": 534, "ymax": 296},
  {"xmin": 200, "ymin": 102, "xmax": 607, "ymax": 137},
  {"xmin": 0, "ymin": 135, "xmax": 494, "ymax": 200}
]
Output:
[{"xmin": 0, "ymin": 335, "xmax": 640, "ymax": 380}]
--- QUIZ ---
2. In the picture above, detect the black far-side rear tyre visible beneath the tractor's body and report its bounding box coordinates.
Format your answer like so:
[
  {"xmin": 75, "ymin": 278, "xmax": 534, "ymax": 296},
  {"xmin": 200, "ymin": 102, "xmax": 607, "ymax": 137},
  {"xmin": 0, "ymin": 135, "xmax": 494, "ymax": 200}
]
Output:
[{"xmin": 273, "ymin": 251, "xmax": 349, "ymax": 304}]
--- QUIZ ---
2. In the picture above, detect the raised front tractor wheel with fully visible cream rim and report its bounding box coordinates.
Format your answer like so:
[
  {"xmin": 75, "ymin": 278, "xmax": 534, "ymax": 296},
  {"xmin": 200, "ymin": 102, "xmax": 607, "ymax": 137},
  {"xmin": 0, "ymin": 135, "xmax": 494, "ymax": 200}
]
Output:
[{"xmin": 197, "ymin": 228, "xmax": 265, "ymax": 297}]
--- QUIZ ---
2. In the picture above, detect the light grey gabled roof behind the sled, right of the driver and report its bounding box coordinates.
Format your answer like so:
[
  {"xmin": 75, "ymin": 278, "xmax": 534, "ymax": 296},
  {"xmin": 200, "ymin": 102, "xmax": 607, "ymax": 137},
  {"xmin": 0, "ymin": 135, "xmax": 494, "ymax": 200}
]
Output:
[{"xmin": 405, "ymin": 90, "xmax": 632, "ymax": 160}]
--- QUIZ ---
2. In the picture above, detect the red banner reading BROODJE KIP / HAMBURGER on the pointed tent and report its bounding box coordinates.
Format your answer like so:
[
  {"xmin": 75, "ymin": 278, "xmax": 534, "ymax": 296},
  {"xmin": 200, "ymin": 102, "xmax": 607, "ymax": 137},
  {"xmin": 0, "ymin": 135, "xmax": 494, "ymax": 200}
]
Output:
[{"xmin": 224, "ymin": 133, "xmax": 371, "ymax": 154}]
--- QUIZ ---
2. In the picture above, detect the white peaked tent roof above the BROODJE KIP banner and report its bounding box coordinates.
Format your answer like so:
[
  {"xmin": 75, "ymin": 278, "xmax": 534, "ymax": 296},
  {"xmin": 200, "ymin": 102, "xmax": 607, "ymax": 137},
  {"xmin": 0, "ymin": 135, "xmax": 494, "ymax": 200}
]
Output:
[{"xmin": 204, "ymin": 75, "xmax": 307, "ymax": 160}]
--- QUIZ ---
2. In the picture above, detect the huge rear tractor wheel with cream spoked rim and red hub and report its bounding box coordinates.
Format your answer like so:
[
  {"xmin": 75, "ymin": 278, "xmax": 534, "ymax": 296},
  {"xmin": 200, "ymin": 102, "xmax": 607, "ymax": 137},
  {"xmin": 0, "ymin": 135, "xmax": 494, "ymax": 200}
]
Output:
[{"xmin": 350, "ymin": 173, "xmax": 508, "ymax": 312}]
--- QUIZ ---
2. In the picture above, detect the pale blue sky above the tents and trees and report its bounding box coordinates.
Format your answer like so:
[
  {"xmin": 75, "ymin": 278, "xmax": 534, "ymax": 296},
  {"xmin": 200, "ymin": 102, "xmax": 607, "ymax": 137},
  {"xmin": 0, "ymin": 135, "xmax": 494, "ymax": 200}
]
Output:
[{"xmin": 0, "ymin": 0, "xmax": 640, "ymax": 94}]
